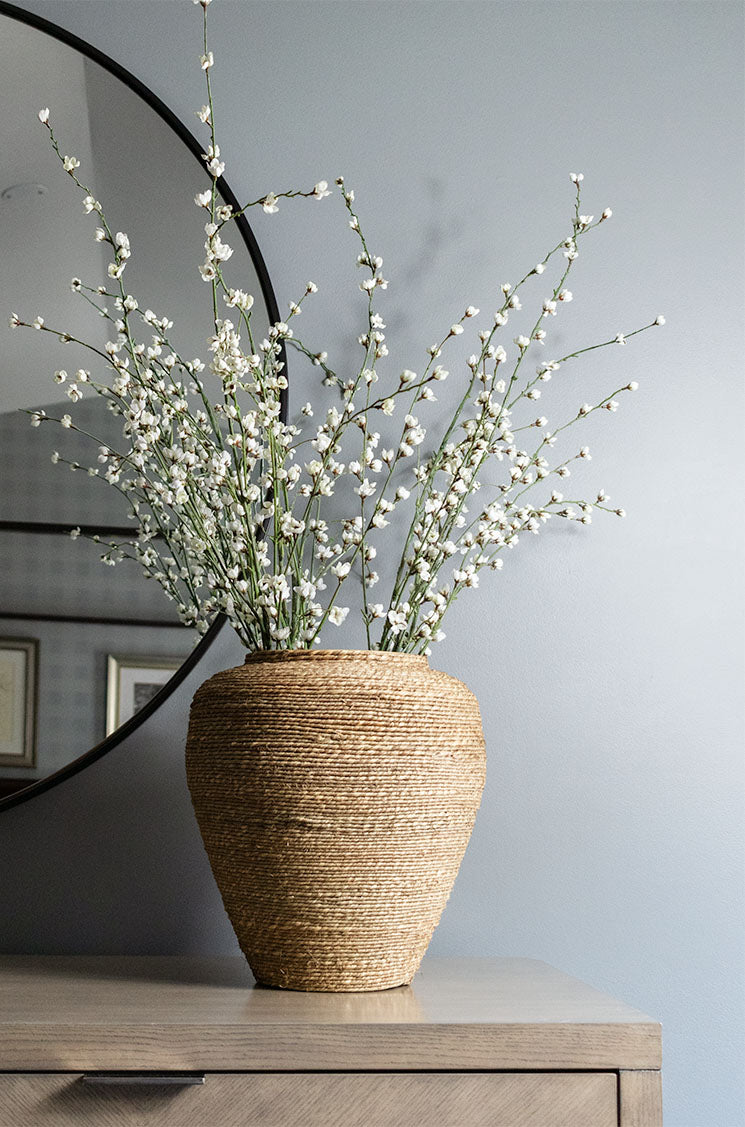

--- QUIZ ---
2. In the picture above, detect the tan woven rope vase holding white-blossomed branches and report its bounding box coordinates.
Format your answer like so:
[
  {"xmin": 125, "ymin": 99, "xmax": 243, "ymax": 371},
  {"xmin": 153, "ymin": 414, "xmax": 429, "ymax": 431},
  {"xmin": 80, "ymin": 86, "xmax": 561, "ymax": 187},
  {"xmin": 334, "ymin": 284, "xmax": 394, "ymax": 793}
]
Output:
[{"xmin": 186, "ymin": 650, "xmax": 486, "ymax": 991}]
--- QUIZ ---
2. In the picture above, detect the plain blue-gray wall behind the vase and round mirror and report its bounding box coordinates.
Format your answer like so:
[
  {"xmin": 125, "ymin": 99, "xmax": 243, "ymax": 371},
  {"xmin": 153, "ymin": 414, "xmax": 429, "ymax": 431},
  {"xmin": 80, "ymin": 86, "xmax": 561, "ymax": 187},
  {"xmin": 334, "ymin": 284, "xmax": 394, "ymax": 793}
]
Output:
[{"xmin": 0, "ymin": 0, "xmax": 745, "ymax": 1127}]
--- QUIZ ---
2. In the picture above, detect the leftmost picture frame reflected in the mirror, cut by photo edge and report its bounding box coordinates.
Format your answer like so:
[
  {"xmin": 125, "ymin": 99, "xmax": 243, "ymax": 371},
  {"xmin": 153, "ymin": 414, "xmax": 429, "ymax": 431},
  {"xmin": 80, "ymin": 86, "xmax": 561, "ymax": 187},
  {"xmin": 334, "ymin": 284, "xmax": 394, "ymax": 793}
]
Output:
[{"xmin": 0, "ymin": 637, "xmax": 38, "ymax": 767}]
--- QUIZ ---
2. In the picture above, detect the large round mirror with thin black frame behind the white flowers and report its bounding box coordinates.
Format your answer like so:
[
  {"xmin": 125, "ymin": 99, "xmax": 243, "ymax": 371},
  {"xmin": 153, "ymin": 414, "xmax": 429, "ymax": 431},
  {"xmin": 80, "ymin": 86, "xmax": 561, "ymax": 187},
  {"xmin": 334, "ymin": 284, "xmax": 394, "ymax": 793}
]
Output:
[{"xmin": 0, "ymin": 2, "xmax": 278, "ymax": 807}]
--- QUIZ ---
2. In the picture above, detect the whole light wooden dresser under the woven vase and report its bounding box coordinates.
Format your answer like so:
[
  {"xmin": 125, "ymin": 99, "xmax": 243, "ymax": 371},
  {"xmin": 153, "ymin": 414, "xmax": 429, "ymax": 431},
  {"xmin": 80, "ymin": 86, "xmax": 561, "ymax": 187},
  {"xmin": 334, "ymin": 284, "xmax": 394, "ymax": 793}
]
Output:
[{"xmin": 0, "ymin": 956, "xmax": 662, "ymax": 1127}]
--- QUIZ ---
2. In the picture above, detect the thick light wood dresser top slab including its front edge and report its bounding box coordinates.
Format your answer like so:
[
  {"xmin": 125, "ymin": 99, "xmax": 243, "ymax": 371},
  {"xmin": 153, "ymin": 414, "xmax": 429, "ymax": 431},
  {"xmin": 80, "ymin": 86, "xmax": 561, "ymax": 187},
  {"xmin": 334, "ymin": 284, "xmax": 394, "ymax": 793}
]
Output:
[{"xmin": 0, "ymin": 956, "xmax": 660, "ymax": 1072}]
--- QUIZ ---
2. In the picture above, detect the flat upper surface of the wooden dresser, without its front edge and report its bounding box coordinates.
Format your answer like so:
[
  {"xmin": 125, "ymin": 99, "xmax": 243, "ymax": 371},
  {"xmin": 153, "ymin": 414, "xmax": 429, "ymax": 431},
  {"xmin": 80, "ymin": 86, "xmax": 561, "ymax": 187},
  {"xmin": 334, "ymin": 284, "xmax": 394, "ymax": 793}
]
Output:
[{"xmin": 0, "ymin": 956, "xmax": 653, "ymax": 1029}]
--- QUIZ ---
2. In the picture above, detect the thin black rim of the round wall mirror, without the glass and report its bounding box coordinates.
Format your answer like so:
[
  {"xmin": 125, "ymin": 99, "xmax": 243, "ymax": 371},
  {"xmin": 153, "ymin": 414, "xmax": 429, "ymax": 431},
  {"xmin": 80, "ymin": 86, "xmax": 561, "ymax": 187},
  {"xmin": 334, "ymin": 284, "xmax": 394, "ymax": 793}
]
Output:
[{"xmin": 0, "ymin": 0, "xmax": 282, "ymax": 813}]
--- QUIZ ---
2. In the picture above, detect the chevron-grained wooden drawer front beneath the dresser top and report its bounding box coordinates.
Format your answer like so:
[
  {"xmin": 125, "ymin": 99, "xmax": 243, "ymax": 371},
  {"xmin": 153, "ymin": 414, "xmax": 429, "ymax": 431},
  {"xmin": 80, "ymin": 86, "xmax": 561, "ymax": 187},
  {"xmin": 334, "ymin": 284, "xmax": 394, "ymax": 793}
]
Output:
[{"xmin": 0, "ymin": 1072, "xmax": 618, "ymax": 1127}]
